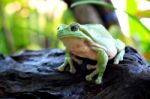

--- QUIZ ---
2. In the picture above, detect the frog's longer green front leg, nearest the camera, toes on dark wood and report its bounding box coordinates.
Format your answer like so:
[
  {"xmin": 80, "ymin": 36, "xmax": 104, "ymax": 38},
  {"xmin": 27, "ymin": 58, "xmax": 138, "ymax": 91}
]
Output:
[{"xmin": 86, "ymin": 48, "xmax": 108, "ymax": 84}]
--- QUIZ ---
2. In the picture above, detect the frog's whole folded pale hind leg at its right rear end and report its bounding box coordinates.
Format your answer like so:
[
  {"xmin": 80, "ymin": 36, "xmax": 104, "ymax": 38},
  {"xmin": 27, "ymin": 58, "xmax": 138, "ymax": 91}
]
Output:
[{"xmin": 114, "ymin": 39, "xmax": 125, "ymax": 64}]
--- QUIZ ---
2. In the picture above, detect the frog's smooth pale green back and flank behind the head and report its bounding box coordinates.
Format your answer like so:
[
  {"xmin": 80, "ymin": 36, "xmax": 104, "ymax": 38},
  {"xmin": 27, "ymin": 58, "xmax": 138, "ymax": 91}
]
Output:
[{"xmin": 81, "ymin": 24, "xmax": 117, "ymax": 59}]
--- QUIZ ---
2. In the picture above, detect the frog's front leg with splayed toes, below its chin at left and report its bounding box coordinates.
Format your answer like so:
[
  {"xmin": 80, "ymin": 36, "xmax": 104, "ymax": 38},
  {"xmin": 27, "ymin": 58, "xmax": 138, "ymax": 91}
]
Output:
[{"xmin": 57, "ymin": 50, "xmax": 76, "ymax": 74}]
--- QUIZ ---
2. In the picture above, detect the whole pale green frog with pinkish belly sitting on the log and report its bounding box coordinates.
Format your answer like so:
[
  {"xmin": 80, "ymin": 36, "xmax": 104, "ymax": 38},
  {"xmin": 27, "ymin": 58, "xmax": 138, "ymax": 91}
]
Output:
[{"xmin": 58, "ymin": 23, "xmax": 125, "ymax": 84}]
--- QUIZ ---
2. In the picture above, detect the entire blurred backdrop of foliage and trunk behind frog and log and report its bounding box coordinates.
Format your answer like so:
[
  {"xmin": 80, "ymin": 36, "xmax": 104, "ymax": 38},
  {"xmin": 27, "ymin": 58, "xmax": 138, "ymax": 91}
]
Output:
[{"xmin": 0, "ymin": 0, "xmax": 150, "ymax": 62}]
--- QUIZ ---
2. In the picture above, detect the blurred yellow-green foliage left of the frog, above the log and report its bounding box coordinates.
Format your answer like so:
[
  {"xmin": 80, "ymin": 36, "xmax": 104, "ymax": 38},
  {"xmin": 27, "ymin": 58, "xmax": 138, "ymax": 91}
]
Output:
[{"xmin": 0, "ymin": 0, "xmax": 75, "ymax": 54}]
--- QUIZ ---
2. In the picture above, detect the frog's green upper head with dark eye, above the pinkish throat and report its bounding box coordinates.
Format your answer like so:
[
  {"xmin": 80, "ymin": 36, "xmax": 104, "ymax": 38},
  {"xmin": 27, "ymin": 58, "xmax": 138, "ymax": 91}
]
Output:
[{"xmin": 57, "ymin": 23, "xmax": 83, "ymax": 38}]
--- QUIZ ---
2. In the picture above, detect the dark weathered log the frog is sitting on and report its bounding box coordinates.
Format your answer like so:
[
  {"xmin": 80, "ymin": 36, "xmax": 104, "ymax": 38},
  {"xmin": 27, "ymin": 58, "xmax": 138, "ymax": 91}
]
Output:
[{"xmin": 0, "ymin": 47, "xmax": 150, "ymax": 99}]
